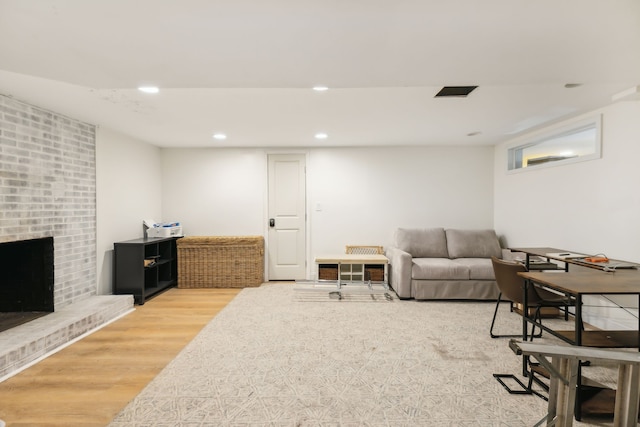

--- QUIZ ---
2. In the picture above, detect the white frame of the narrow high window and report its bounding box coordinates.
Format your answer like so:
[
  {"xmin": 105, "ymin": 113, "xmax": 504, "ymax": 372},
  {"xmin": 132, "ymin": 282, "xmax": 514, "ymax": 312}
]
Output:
[{"xmin": 506, "ymin": 114, "xmax": 602, "ymax": 173}]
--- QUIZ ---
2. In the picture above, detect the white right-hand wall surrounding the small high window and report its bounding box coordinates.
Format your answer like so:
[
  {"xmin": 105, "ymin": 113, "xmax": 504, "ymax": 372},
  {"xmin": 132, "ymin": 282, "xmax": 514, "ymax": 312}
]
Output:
[{"xmin": 494, "ymin": 101, "xmax": 640, "ymax": 328}]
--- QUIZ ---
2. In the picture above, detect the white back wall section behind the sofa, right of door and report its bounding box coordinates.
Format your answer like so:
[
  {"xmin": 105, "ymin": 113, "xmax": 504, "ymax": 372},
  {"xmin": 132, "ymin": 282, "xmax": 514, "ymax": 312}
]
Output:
[{"xmin": 307, "ymin": 147, "xmax": 493, "ymax": 259}]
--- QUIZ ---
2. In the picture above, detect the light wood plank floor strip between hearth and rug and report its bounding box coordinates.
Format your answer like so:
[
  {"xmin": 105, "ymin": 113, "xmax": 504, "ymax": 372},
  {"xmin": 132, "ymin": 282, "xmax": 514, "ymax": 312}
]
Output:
[{"xmin": 0, "ymin": 288, "xmax": 241, "ymax": 427}]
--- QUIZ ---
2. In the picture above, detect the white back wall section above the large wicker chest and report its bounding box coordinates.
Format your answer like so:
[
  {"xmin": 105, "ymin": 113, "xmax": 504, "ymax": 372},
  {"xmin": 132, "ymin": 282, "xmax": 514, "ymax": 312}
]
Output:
[{"xmin": 162, "ymin": 148, "xmax": 267, "ymax": 236}]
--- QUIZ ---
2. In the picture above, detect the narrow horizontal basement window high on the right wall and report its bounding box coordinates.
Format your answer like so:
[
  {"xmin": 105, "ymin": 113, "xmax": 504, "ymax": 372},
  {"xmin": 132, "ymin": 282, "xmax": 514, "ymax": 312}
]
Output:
[{"xmin": 507, "ymin": 116, "xmax": 602, "ymax": 172}]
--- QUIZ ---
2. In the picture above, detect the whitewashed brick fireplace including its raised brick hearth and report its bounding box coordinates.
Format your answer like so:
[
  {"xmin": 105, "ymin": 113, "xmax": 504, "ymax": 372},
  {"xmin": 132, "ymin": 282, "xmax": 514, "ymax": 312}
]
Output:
[{"xmin": 0, "ymin": 94, "xmax": 133, "ymax": 380}]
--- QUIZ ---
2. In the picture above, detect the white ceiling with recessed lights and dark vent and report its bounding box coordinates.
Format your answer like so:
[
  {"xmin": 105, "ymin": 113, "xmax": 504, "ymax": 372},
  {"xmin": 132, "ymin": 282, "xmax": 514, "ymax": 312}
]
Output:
[{"xmin": 0, "ymin": 0, "xmax": 640, "ymax": 147}]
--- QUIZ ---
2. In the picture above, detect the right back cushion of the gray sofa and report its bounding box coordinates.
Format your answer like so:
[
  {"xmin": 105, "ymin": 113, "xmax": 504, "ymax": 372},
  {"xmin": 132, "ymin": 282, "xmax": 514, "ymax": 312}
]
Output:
[{"xmin": 446, "ymin": 229, "xmax": 502, "ymax": 258}]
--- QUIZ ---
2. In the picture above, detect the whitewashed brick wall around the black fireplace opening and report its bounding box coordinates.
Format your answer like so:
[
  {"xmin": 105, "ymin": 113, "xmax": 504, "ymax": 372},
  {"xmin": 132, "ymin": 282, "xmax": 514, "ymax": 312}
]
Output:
[{"xmin": 0, "ymin": 95, "xmax": 96, "ymax": 310}]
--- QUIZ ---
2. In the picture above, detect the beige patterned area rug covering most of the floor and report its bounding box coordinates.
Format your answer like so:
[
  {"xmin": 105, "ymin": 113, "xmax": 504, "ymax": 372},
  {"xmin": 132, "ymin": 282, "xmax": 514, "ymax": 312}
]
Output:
[{"xmin": 110, "ymin": 284, "xmax": 612, "ymax": 427}]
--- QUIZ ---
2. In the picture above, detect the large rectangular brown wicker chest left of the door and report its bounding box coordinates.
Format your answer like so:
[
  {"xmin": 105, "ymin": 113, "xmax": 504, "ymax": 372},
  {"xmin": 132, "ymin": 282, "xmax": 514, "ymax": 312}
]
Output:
[{"xmin": 176, "ymin": 236, "xmax": 264, "ymax": 288}]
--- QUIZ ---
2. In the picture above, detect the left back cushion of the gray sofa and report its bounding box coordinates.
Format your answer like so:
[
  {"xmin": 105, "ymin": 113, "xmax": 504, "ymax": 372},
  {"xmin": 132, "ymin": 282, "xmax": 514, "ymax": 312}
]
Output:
[{"xmin": 395, "ymin": 228, "xmax": 449, "ymax": 258}]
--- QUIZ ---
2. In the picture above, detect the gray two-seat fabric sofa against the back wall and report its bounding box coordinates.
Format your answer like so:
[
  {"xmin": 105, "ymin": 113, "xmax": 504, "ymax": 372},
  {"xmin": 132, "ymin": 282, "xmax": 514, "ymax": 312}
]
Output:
[{"xmin": 385, "ymin": 228, "xmax": 503, "ymax": 300}]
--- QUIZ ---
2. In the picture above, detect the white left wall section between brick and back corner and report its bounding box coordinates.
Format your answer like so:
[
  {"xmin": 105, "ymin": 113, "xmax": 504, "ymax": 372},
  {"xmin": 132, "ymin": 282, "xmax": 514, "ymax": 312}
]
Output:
[{"xmin": 96, "ymin": 128, "xmax": 162, "ymax": 295}]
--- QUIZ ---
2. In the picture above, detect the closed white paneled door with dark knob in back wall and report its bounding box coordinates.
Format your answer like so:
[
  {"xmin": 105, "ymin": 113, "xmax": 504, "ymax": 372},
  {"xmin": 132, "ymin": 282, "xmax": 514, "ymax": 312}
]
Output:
[{"xmin": 268, "ymin": 154, "xmax": 306, "ymax": 280}]
